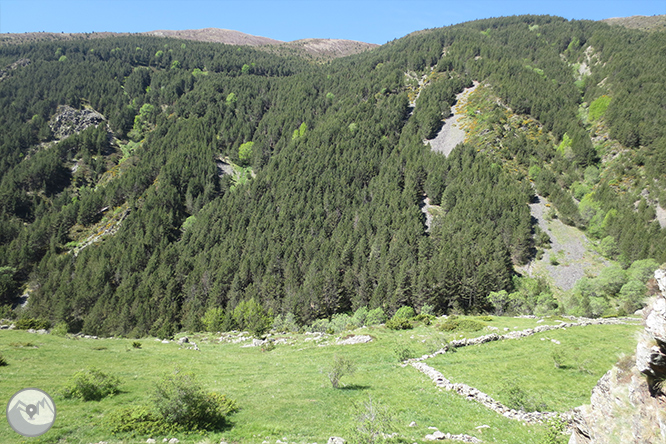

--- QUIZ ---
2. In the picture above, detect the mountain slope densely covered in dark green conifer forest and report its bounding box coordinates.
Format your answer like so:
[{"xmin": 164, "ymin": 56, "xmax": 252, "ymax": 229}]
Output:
[{"xmin": 0, "ymin": 16, "xmax": 666, "ymax": 336}]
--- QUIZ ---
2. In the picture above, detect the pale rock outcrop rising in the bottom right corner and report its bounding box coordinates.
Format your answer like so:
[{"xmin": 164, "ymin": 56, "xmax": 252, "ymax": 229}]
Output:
[{"xmin": 569, "ymin": 266, "xmax": 666, "ymax": 444}]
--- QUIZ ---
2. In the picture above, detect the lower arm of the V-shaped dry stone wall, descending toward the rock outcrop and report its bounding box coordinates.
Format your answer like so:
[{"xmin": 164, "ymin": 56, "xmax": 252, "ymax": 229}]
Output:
[{"xmin": 412, "ymin": 362, "xmax": 559, "ymax": 424}]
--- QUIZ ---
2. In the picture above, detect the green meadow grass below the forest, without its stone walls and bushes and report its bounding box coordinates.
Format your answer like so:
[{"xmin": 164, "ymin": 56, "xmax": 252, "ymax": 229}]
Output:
[{"xmin": 0, "ymin": 318, "xmax": 637, "ymax": 444}]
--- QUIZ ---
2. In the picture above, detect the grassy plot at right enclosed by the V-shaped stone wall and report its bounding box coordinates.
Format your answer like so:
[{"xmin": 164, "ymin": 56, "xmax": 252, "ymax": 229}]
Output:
[{"xmin": 428, "ymin": 325, "xmax": 637, "ymax": 412}]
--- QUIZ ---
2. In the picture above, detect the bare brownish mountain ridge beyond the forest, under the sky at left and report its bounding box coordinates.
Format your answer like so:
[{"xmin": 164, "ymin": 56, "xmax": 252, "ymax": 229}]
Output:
[{"xmin": 0, "ymin": 28, "xmax": 379, "ymax": 59}]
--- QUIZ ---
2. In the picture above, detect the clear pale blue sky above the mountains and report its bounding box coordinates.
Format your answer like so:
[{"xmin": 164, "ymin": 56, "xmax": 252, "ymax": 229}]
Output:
[{"xmin": 0, "ymin": 0, "xmax": 666, "ymax": 44}]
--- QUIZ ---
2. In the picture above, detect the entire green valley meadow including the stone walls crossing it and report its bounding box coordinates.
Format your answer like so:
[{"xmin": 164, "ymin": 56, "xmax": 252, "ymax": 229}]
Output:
[{"xmin": 0, "ymin": 316, "xmax": 638, "ymax": 444}]
